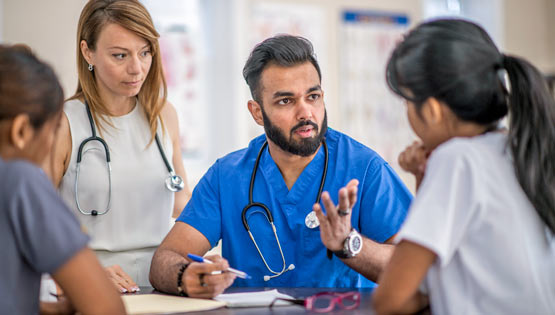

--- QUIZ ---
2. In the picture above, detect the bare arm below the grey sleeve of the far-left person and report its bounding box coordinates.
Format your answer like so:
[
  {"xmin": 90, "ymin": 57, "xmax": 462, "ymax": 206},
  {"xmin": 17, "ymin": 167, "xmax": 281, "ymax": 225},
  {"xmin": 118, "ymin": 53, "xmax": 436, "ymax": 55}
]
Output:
[{"xmin": 52, "ymin": 248, "xmax": 125, "ymax": 314}]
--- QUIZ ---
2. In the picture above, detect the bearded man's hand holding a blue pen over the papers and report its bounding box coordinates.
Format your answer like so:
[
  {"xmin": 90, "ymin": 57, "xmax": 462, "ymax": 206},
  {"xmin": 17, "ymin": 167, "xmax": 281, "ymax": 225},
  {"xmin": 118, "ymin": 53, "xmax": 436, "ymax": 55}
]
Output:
[{"xmin": 183, "ymin": 255, "xmax": 236, "ymax": 298}]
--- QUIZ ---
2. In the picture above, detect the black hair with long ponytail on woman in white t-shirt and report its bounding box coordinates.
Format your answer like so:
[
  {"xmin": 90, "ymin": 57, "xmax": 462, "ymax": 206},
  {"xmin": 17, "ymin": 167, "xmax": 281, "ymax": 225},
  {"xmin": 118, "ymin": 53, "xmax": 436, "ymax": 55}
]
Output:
[{"xmin": 386, "ymin": 19, "xmax": 555, "ymax": 234}]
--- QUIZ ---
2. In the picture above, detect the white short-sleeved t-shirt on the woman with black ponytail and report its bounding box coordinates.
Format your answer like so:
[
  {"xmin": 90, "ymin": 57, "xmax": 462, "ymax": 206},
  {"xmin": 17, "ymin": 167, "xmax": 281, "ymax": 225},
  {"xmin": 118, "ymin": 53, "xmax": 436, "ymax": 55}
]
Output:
[{"xmin": 397, "ymin": 133, "xmax": 555, "ymax": 314}]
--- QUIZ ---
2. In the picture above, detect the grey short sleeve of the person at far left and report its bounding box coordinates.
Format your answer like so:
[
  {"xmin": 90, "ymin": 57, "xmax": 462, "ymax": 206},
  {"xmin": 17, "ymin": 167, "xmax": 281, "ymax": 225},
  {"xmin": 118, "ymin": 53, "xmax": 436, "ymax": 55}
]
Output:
[{"xmin": 8, "ymin": 162, "xmax": 89, "ymax": 273}]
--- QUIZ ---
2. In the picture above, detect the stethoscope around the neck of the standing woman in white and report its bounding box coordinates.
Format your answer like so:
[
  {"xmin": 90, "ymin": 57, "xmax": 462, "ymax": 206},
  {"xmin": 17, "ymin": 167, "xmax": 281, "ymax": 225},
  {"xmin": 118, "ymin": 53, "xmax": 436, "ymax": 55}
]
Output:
[{"xmin": 75, "ymin": 100, "xmax": 185, "ymax": 216}]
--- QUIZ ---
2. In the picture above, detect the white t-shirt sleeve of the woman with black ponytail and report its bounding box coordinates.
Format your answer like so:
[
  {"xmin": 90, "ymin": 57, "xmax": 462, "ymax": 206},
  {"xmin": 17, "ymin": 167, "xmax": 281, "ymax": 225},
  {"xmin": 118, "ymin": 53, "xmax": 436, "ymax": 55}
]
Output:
[{"xmin": 397, "ymin": 145, "xmax": 479, "ymax": 266}]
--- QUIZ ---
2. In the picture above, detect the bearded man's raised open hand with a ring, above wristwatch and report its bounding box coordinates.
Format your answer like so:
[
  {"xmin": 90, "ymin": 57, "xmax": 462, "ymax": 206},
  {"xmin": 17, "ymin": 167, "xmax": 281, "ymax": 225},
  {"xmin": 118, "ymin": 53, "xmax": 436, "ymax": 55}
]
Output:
[{"xmin": 312, "ymin": 179, "xmax": 358, "ymax": 251}]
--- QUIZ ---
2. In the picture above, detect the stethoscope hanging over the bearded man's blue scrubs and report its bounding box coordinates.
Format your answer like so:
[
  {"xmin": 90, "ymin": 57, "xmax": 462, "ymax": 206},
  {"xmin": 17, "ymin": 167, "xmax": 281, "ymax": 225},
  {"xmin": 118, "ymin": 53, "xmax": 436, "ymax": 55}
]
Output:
[{"xmin": 241, "ymin": 139, "xmax": 328, "ymax": 281}]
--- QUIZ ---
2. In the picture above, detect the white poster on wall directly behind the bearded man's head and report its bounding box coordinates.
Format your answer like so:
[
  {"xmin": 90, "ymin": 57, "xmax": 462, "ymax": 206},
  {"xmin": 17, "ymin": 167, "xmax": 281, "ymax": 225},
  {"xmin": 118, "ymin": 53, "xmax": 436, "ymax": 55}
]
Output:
[{"xmin": 247, "ymin": 2, "xmax": 328, "ymax": 138}]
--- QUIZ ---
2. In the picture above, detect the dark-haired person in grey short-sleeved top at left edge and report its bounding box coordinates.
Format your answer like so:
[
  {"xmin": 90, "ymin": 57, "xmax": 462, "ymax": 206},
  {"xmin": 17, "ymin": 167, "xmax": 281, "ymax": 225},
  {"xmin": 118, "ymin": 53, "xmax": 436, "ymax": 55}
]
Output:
[{"xmin": 0, "ymin": 46, "xmax": 125, "ymax": 314}]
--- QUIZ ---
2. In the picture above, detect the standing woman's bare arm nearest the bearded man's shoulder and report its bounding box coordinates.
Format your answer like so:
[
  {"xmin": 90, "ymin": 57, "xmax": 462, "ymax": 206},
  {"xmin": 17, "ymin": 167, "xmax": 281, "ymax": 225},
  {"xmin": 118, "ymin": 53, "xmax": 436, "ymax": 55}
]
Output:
[{"xmin": 161, "ymin": 102, "xmax": 191, "ymax": 218}]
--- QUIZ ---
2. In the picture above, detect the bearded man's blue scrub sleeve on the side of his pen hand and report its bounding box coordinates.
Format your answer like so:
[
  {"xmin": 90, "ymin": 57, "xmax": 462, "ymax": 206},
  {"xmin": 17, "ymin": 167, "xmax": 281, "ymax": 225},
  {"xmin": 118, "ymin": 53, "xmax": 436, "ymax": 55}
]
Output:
[{"xmin": 176, "ymin": 162, "xmax": 221, "ymax": 247}]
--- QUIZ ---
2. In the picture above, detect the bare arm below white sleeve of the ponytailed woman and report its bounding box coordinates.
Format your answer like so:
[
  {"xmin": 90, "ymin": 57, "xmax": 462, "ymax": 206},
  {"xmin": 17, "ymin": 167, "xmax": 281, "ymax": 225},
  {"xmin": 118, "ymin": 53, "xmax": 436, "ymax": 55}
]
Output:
[{"xmin": 372, "ymin": 240, "xmax": 436, "ymax": 314}]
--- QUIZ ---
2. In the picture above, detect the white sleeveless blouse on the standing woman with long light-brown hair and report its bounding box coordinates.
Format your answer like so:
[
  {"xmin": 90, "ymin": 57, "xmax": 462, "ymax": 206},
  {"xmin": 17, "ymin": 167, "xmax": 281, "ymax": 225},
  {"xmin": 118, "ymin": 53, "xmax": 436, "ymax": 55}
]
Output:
[{"xmin": 60, "ymin": 100, "xmax": 174, "ymax": 284}]
